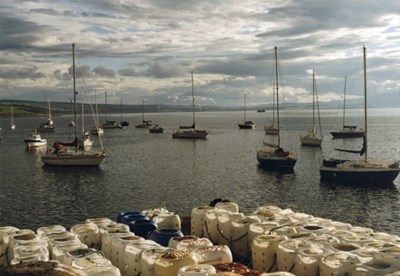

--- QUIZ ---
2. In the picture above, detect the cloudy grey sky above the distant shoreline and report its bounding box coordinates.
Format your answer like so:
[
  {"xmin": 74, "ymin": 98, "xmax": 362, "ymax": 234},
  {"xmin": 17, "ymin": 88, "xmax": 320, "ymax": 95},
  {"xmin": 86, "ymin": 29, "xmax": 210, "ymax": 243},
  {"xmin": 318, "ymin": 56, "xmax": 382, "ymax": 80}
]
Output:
[{"xmin": 0, "ymin": 0, "xmax": 400, "ymax": 106}]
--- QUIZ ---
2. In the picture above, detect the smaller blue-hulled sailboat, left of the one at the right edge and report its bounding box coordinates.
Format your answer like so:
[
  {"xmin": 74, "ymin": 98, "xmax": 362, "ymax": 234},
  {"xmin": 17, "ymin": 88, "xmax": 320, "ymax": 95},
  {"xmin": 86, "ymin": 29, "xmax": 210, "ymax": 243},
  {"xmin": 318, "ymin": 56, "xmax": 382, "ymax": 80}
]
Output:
[{"xmin": 257, "ymin": 47, "xmax": 297, "ymax": 170}]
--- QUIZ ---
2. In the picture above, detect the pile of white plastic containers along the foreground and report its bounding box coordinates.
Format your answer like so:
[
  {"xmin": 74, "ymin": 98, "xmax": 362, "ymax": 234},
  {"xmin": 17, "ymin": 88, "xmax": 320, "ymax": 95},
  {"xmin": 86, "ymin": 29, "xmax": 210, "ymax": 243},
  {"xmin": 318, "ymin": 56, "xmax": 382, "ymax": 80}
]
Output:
[{"xmin": 0, "ymin": 201, "xmax": 400, "ymax": 276}]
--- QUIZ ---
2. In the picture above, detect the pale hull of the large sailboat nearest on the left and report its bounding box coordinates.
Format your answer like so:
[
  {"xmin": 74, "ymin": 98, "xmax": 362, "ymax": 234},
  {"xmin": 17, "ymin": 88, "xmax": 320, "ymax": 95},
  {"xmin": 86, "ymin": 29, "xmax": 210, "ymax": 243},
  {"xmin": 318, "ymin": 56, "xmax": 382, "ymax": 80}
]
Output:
[{"xmin": 42, "ymin": 153, "xmax": 105, "ymax": 166}]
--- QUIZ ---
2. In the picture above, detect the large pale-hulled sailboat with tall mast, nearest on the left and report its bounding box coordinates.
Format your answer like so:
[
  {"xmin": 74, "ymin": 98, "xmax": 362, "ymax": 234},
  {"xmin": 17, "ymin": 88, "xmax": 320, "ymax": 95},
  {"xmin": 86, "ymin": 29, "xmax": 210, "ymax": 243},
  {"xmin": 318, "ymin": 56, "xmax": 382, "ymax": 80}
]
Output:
[{"xmin": 42, "ymin": 43, "xmax": 105, "ymax": 166}]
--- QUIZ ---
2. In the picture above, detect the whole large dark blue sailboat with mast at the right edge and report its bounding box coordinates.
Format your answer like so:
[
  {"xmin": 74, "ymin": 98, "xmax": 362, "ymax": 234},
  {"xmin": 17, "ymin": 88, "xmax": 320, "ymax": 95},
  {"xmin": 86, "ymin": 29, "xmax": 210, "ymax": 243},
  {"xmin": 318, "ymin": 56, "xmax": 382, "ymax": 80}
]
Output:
[{"xmin": 319, "ymin": 46, "xmax": 400, "ymax": 186}]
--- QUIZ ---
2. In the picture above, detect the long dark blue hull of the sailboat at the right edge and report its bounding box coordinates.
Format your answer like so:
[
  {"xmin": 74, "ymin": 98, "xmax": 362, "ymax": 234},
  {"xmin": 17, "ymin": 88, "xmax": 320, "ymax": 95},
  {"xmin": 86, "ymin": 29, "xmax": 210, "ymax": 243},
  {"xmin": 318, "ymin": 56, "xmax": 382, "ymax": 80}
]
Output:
[{"xmin": 319, "ymin": 160, "xmax": 400, "ymax": 185}]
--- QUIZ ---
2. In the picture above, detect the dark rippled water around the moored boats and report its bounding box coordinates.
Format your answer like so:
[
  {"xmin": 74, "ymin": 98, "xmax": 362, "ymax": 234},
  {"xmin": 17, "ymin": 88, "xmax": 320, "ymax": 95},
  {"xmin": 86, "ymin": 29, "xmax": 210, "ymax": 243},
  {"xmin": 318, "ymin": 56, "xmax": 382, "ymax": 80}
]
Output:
[{"xmin": 0, "ymin": 109, "xmax": 400, "ymax": 235}]
